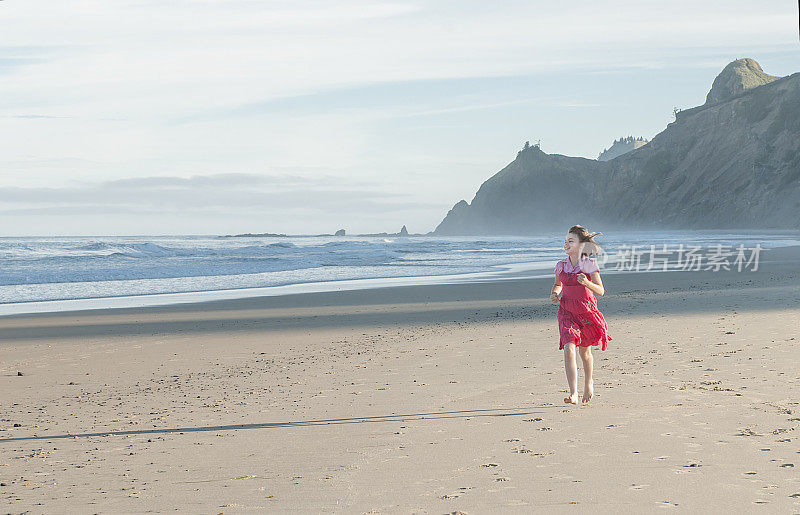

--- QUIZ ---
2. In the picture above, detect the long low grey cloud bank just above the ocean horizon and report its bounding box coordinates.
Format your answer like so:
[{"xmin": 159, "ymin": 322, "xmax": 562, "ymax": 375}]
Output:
[{"xmin": 0, "ymin": 173, "xmax": 438, "ymax": 216}]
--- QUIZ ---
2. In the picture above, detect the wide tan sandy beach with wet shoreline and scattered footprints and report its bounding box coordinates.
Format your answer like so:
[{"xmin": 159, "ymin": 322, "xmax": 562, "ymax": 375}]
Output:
[{"xmin": 0, "ymin": 247, "xmax": 800, "ymax": 514}]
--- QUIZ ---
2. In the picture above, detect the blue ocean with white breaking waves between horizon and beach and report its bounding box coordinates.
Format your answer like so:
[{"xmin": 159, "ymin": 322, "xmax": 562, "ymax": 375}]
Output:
[{"xmin": 0, "ymin": 231, "xmax": 800, "ymax": 314}]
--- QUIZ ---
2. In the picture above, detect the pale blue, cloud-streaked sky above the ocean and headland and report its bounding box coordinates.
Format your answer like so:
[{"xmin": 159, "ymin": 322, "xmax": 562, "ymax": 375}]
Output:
[{"xmin": 0, "ymin": 0, "xmax": 800, "ymax": 236}]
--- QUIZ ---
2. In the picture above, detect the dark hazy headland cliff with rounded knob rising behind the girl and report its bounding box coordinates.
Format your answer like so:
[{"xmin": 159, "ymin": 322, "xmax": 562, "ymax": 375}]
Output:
[{"xmin": 434, "ymin": 59, "xmax": 800, "ymax": 235}]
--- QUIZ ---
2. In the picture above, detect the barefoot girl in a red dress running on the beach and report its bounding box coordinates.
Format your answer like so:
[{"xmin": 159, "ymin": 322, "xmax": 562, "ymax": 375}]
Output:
[{"xmin": 550, "ymin": 225, "xmax": 612, "ymax": 404}]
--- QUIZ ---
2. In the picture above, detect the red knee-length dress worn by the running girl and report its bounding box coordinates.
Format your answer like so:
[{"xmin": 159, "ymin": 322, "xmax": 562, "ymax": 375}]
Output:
[{"xmin": 555, "ymin": 257, "xmax": 613, "ymax": 350}]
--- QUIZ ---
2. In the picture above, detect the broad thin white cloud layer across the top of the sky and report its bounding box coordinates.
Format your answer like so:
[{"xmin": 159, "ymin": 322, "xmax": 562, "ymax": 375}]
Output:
[{"xmin": 3, "ymin": 0, "xmax": 796, "ymax": 118}]
